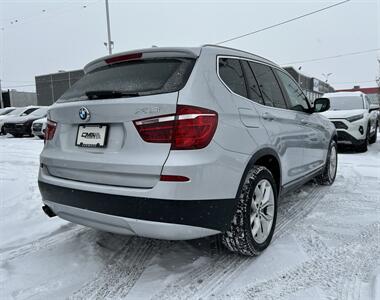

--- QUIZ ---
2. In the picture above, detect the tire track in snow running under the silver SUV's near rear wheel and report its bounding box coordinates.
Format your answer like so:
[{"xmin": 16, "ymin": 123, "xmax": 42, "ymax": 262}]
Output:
[{"xmin": 152, "ymin": 186, "xmax": 325, "ymax": 299}]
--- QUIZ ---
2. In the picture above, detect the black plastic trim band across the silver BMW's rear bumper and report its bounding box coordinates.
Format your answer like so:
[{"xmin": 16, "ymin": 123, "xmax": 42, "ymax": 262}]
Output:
[{"xmin": 38, "ymin": 181, "xmax": 237, "ymax": 232}]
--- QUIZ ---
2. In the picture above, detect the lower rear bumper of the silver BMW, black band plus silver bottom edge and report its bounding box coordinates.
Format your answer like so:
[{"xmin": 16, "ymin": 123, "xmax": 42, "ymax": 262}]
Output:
[{"xmin": 39, "ymin": 181, "xmax": 236, "ymax": 240}]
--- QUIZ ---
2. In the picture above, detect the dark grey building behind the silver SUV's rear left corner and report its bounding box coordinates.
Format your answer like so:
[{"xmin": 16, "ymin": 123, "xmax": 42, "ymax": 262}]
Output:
[{"xmin": 35, "ymin": 70, "xmax": 84, "ymax": 105}]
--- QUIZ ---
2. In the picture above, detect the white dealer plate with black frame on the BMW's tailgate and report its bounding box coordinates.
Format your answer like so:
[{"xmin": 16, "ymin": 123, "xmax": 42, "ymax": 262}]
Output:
[{"xmin": 75, "ymin": 124, "xmax": 109, "ymax": 148}]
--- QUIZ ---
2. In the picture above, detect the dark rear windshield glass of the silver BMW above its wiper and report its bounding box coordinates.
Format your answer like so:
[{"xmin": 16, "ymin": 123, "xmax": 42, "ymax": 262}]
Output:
[{"xmin": 58, "ymin": 58, "xmax": 195, "ymax": 102}]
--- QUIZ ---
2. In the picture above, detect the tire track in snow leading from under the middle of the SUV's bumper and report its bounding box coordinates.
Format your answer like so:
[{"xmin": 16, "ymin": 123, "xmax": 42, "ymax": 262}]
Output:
[{"xmin": 69, "ymin": 237, "xmax": 172, "ymax": 299}]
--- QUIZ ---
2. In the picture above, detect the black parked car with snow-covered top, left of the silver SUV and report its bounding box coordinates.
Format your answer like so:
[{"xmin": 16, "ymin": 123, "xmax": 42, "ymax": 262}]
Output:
[{"xmin": 3, "ymin": 107, "xmax": 48, "ymax": 137}]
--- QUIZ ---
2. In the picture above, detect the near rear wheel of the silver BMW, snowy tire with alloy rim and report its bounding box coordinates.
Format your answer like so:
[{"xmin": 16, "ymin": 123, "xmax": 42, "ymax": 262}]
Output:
[{"xmin": 222, "ymin": 166, "xmax": 278, "ymax": 256}]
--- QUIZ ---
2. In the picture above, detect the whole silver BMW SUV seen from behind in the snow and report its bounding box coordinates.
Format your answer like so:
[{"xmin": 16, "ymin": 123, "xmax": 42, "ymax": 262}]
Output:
[{"xmin": 39, "ymin": 45, "xmax": 337, "ymax": 255}]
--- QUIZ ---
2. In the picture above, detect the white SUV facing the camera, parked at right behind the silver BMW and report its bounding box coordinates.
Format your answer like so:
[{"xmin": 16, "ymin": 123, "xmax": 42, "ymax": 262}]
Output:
[{"xmin": 322, "ymin": 92, "xmax": 379, "ymax": 152}]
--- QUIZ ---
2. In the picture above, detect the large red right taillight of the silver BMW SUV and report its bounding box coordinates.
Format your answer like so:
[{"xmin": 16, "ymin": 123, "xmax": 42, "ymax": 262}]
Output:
[{"xmin": 134, "ymin": 105, "xmax": 218, "ymax": 150}]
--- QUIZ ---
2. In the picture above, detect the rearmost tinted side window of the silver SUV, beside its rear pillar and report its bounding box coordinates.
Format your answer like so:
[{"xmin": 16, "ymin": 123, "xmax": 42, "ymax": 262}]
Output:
[{"xmin": 219, "ymin": 58, "xmax": 247, "ymax": 97}]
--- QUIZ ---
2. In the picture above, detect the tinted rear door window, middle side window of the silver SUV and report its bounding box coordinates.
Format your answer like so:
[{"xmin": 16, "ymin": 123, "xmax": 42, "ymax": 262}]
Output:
[{"xmin": 249, "ymin": 62, "xmax": 286, "ymax": 108}]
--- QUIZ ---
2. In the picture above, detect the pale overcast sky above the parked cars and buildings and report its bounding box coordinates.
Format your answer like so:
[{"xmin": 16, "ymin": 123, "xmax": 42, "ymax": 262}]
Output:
[{"xmin": 0, "ymin": 0, "xmax": 380, "ymax": 90}]
